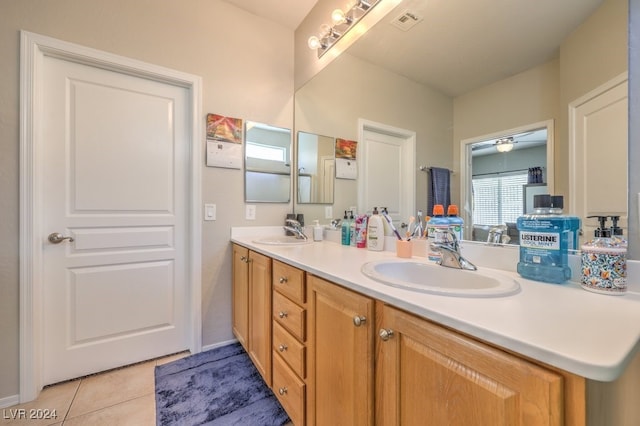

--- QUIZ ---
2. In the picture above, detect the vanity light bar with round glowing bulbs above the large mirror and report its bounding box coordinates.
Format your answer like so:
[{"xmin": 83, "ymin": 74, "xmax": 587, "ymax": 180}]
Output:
[{"xmin": 307, "ymin": 0, "xmax": 382, "ymax": 58}]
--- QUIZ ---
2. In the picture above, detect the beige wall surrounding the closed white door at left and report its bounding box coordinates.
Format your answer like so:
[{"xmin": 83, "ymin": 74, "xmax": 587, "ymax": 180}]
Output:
[{"xmin": 0, "ymin": 0, "xmax": 293, "ymax": 401}]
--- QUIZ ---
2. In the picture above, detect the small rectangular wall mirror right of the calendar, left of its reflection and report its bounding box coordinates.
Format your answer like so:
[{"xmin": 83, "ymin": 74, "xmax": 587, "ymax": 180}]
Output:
[{"xmin": 244, "ymin": 121, "xmax": 291, "ymax": 203}]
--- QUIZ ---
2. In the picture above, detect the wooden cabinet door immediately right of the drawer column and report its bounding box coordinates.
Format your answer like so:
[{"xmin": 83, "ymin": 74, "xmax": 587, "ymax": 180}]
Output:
[{"xmin": 307, "ymin": 275, "xmax": 375, "ymax": 426}]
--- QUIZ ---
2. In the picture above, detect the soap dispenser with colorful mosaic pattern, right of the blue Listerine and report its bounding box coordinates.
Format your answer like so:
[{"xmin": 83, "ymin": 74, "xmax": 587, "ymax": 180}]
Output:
[{"xmin": 580, "ymin": 216, "xmax": 627, "ymax": 295}]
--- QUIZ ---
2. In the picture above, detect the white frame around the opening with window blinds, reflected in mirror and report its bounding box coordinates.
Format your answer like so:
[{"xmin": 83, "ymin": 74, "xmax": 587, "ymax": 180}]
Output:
[{"xmin": 460, "ymin": 119, "xmax": 561, "ymax": 240}]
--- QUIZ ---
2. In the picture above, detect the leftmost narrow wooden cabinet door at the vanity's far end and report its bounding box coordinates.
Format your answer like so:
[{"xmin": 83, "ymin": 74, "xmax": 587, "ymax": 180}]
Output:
[{"xmin": 231, "ymin": 244, "xmax": 249, "ymax": 350}]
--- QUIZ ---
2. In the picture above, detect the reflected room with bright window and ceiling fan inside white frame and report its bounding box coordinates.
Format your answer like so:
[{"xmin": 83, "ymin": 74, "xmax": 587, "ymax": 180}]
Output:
[{"xmin": 470, "ymin": 127, "xmax": 548, "ymax": 244}]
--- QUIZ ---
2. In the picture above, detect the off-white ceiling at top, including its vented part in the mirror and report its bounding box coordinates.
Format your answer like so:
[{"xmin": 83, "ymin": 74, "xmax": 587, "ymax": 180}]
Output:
[{"xmin": 225, "ymin": 0, "xmax": 603, "ymax": 96}]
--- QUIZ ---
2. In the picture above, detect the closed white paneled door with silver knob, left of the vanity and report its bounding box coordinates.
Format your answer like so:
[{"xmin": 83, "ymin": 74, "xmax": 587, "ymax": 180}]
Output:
[{"xmin": 39, "ymin": 52, "xmax": 190, "ymax": 384}]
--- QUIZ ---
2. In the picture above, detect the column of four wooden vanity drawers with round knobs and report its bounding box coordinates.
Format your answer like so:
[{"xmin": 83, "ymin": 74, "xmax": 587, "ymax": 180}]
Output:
[{"xmin": 272, "ymin": 260, "xmax": 307, "ymax": 426}]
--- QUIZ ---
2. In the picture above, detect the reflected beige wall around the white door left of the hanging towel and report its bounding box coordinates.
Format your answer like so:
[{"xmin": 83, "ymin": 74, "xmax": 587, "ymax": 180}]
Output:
[{"xmin": 295, "ymin": 54, "xmax": 453, "ymax": 223}]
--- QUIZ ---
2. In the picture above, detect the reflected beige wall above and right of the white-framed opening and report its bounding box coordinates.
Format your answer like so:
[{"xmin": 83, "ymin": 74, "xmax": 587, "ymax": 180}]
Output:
[{"xmin": 453, "ymin": 0, "xmax": 628, "ymax": 213}]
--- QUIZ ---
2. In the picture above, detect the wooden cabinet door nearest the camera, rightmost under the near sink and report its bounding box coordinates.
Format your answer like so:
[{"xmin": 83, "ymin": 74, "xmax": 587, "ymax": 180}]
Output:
[{"xmin": 376, "ymin": 304, "xmax": 563, "ymax": 426}]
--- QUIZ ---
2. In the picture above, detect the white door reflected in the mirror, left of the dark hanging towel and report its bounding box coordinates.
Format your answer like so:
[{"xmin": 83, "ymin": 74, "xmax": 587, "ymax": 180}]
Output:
[{"xmin": 357, "ymin": 120, "xmax": 416, "ymax": 229}]
